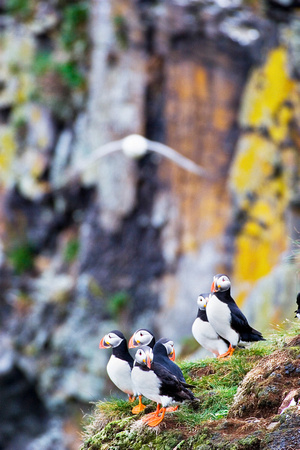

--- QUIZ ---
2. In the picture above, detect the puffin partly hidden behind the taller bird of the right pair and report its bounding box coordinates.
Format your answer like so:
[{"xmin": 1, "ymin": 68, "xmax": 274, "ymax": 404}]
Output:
[{"xmin": 192, "ymin": 293, "xmax": 230, "ymax": 357}]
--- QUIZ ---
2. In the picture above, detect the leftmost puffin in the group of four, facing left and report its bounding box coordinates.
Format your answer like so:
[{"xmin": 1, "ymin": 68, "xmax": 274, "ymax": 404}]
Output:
[{"xmin": 99, "ymin": 330, "xmax": 145, "ymax": 414}]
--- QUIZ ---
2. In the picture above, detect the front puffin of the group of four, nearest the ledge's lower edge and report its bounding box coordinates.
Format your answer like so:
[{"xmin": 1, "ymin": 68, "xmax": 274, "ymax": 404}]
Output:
[{"xmin": 131, "ymin": 345, "xmax": 195, "ymax": 427}]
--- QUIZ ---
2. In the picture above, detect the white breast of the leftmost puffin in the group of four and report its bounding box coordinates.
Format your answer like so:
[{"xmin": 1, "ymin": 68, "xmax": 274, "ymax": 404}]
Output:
[{"xmin": 106, "ymin": 355, "xmax": 134, "ymax": 395}]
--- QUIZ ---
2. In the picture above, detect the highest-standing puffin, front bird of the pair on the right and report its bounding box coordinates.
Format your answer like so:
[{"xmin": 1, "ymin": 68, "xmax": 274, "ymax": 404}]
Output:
[{"xmin": 206, "ymin": 274, "xmax": 265, "ymax": 358}]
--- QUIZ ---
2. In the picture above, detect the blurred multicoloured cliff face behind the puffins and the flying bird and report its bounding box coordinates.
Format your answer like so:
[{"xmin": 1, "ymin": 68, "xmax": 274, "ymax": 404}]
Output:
[{"xmin": 0, "ymin": 0, "xmax": 300, "ymax": 450}]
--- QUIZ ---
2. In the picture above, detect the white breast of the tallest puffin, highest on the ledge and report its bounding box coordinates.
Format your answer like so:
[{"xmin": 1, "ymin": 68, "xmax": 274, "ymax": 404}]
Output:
[{"xmin": 206, "ymin": 295, "xmax": 239, "ymax": 346}]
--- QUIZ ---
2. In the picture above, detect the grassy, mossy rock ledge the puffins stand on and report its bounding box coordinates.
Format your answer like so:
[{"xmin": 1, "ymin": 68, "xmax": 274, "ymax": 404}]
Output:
[{"xmin": 81, "ymin": 324, "xmax": 300, "ymax": 450}]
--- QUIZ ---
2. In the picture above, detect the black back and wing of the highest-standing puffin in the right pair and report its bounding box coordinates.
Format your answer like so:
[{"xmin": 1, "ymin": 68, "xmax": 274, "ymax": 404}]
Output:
[{"xmin": 214, "ymin": 288, "xmax": 265, "ymax": 342}]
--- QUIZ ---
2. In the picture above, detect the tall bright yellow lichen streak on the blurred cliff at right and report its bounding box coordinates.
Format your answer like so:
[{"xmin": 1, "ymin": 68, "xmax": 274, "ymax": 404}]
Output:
[{"xmin": 229, "ymin": 47, "xmax": 299, "ymax": 304}]
